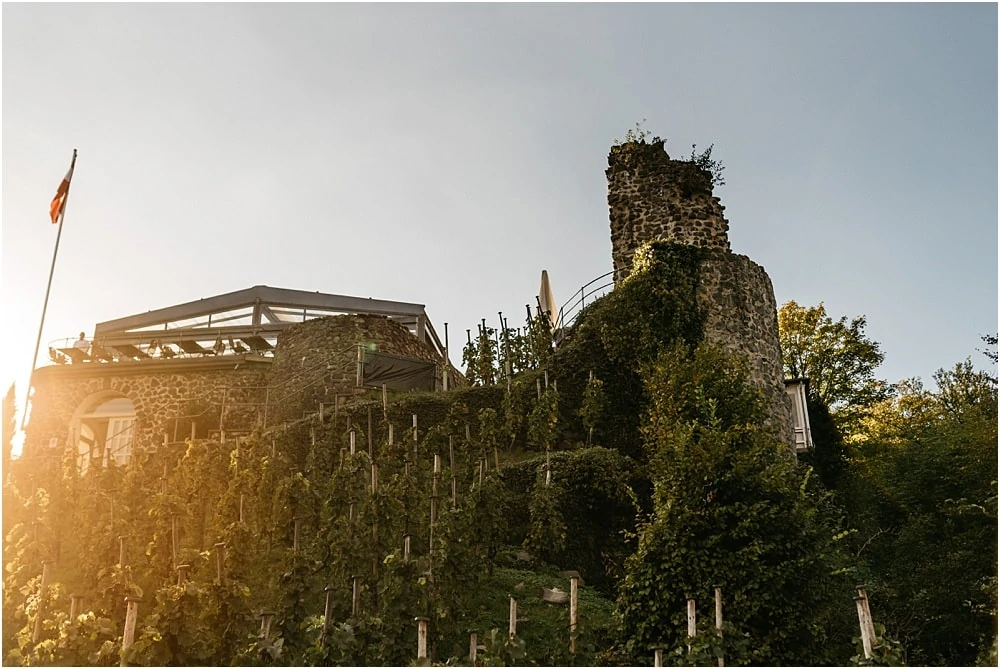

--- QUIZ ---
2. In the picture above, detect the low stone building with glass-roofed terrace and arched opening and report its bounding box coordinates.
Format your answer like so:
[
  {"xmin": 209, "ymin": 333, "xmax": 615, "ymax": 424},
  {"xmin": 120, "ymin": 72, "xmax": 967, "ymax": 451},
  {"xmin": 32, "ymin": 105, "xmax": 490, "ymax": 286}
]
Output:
[{"xmin": 24, "ymin": 286, "xmax": 464, "ymax": 469}]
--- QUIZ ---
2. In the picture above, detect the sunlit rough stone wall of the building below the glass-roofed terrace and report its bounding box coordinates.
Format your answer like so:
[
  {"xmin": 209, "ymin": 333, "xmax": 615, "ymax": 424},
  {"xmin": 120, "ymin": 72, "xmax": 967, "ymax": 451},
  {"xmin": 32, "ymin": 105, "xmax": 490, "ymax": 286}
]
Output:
[{"xmin": 25, "ymin": 316, "xmax": 465, "ymax": 460}]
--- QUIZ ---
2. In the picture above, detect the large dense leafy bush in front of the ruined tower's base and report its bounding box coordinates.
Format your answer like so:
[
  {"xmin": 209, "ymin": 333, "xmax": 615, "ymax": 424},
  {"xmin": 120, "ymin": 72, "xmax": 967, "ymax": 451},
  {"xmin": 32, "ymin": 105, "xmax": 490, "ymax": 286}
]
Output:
[{"xmin": 618, "ymin": 345, "xmax": 851, "ymax": 665}]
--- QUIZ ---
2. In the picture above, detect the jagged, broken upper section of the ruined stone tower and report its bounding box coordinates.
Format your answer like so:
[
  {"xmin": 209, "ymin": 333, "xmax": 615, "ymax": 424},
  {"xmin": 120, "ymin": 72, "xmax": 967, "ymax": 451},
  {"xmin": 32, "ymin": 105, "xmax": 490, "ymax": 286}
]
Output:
[{"xmin": 605, "ymin": 141, "xmax": 729, "ymax": 280}]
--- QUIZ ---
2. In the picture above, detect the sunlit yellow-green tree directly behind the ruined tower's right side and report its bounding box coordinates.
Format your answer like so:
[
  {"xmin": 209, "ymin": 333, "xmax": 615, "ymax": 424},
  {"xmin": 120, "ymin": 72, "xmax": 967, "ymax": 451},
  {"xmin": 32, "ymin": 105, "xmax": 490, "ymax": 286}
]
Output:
[{"xmin": 778, "ymin": 301, "xmax": 891, "ymax": 440}]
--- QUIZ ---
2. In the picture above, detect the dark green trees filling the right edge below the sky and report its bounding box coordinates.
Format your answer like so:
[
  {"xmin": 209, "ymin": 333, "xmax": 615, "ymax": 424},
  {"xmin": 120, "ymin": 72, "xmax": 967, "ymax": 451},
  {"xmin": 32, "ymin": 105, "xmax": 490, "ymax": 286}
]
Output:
[{"xmin": 839, "ymin": 360, "xmax": 998, "ymax": 665}]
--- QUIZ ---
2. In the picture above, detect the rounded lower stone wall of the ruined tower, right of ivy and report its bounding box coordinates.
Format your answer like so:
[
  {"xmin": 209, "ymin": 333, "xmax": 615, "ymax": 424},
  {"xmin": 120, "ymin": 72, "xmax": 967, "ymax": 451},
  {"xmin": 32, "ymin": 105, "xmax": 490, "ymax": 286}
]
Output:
[{"xmin": 698, "ymin": 253, "xmax": 794, "ymax": 444}]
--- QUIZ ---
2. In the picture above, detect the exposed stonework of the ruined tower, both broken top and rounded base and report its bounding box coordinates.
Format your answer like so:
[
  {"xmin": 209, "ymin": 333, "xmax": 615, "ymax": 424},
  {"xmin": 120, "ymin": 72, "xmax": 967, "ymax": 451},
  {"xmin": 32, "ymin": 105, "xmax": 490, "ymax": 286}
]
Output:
[{"xmin": 606, "ymin": 139, "xmax": 794, "ymax": 445}]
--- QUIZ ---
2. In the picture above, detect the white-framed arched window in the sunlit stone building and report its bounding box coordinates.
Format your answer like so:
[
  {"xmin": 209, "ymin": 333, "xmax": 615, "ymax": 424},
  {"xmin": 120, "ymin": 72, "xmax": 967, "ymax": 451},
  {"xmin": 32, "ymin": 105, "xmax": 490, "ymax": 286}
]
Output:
[{"xmin": 76, "ymin": 395, "xmax": 135, "ymax": 472}]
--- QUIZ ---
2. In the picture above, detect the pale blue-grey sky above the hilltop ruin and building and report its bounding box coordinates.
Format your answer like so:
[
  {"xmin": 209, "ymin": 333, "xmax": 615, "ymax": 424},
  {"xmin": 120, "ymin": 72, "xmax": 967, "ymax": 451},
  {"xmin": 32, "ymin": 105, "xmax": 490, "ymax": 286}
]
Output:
[{"xmin": 0, "ymin": 4, "xmax": 997, "ymax": 418}]
